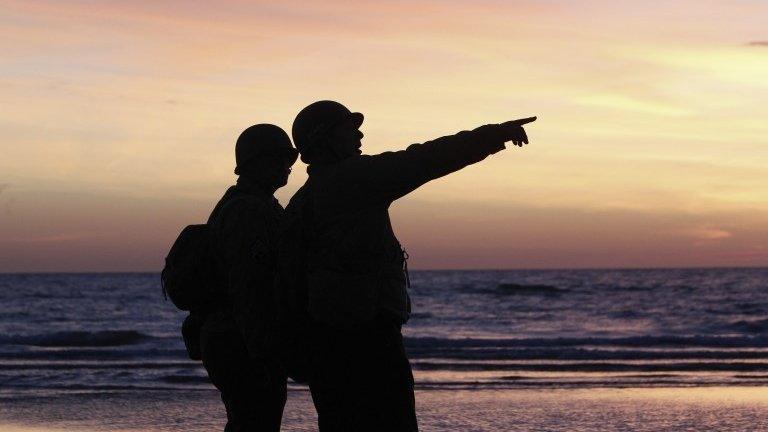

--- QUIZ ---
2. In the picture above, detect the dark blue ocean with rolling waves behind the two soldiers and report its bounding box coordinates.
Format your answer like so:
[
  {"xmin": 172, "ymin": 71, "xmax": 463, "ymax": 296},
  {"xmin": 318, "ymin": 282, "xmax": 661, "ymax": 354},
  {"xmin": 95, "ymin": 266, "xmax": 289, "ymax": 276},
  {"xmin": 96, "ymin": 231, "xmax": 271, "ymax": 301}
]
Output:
[{"xmin": 0, "ymin": 268, "xmax": 768, "ymax": 430}]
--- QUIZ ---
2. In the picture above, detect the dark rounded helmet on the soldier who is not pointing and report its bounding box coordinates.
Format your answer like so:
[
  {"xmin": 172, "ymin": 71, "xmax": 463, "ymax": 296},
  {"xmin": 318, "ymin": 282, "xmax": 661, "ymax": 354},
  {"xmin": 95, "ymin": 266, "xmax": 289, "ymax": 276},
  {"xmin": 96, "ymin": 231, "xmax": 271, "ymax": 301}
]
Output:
[{"xmin": 235, "ymin": 123, "xmax": 299, "ymax": 175}]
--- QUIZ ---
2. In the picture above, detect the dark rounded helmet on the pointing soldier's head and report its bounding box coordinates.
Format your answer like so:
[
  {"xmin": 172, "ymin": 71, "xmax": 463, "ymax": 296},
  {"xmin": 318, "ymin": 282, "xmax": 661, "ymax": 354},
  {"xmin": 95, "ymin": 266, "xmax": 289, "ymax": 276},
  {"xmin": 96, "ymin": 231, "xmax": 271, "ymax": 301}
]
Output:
[{"xmin": 291, "ymin": 100, "xmax": 363, "ymax": 155}]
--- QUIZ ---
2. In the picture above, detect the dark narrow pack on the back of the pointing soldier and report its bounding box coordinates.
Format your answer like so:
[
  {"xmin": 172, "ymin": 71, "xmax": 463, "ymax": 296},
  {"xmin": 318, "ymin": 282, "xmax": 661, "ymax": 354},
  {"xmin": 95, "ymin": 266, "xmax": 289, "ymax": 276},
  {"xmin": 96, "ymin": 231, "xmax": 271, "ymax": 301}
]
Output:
[{"xmin": 274, "ymin": 185, "xmax": 313, "ymax": 383}]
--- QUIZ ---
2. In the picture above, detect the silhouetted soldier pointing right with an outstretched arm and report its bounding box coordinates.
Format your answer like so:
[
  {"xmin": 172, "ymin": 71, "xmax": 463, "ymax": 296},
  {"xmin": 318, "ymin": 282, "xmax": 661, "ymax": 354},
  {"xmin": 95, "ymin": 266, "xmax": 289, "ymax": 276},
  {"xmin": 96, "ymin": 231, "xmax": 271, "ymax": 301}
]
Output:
[{"xmin": 286, "ymin": 101, "xmax": 535, "ymax": 432}]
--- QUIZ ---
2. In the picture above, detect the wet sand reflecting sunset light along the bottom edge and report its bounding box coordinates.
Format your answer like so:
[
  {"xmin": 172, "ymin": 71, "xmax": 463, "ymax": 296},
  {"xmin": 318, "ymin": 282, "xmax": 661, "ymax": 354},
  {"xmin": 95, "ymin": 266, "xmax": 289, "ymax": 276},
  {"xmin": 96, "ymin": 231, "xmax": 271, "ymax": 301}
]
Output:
[{"xmin": 0, "ymin": 387, "xmax": 768, "ymax": 432}]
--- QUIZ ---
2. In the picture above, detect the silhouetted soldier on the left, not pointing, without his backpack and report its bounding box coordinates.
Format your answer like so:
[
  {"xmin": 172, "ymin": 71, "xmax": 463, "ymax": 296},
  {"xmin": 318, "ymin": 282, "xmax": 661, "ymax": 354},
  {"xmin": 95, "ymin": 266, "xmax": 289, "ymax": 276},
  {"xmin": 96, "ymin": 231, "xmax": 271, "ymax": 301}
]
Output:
[{"xmin": 201, "ymin": 124, "xmax": 298, "ymax": 432}]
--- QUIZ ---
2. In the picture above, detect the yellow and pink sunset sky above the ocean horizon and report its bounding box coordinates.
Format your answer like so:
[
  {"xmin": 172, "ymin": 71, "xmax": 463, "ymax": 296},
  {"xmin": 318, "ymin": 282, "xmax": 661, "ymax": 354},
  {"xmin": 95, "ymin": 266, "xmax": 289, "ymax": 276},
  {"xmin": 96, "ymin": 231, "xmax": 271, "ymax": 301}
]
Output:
[{"xmin": 0, "ymin": 0, "xmax": 768, "ymax": 272}]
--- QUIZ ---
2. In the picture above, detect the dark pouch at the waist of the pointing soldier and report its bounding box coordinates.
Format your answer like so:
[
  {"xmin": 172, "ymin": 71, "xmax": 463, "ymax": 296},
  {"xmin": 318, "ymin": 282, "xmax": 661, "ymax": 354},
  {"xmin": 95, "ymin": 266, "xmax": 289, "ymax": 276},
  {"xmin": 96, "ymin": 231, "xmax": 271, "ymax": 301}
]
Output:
[{"xmin": 307, "ymin": 269, "xmax": 382, "ymax": 328}]
